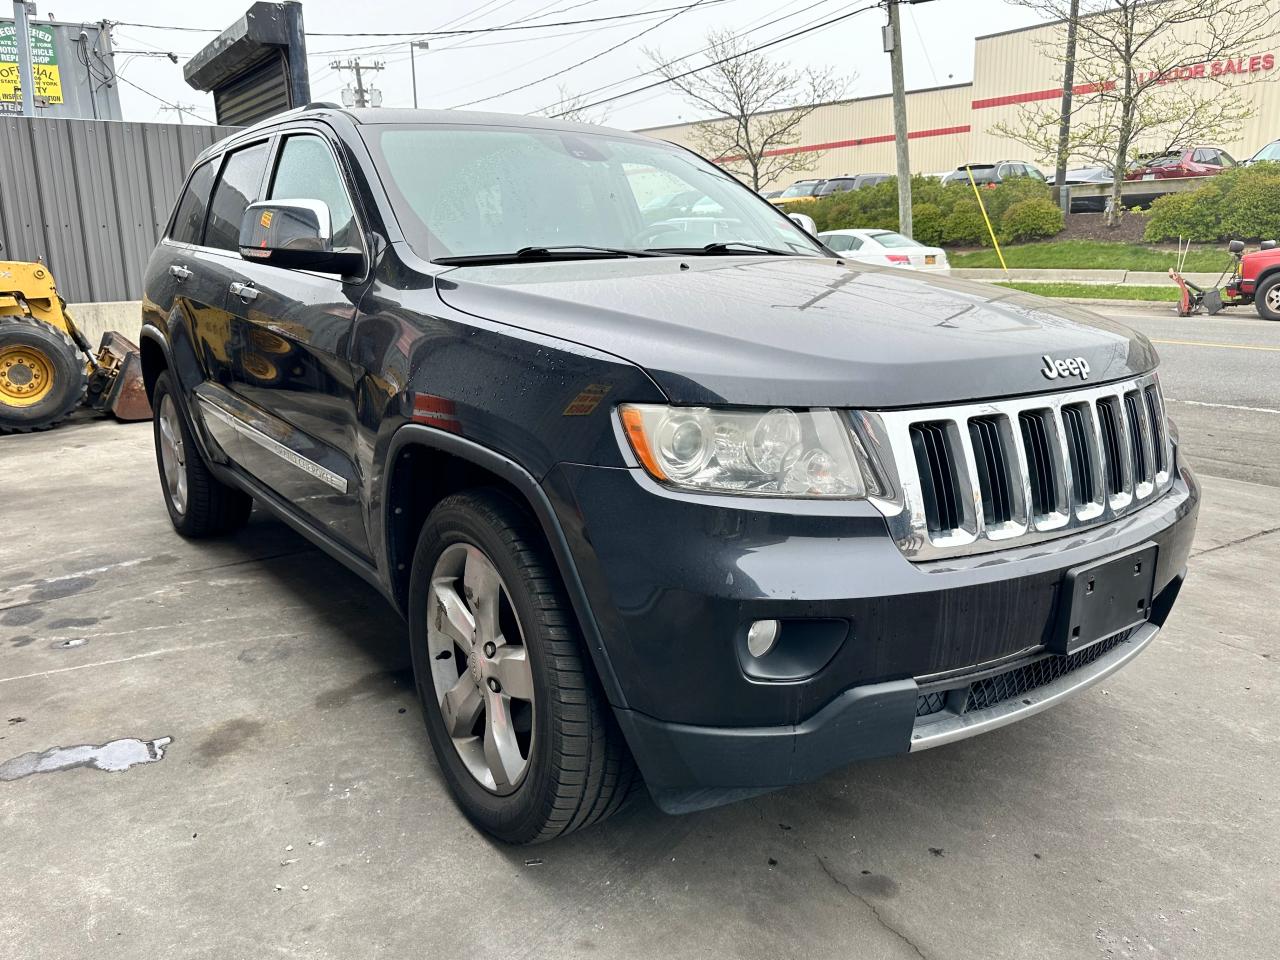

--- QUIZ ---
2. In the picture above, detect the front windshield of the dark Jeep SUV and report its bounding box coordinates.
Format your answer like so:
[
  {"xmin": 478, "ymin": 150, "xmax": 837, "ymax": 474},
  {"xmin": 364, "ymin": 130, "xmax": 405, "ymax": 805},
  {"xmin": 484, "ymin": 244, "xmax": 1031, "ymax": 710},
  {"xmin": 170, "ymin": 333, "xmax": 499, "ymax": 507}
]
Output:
[{"xmin": 361, "ymin": 124, "xmax": 822, "ymax": 260}]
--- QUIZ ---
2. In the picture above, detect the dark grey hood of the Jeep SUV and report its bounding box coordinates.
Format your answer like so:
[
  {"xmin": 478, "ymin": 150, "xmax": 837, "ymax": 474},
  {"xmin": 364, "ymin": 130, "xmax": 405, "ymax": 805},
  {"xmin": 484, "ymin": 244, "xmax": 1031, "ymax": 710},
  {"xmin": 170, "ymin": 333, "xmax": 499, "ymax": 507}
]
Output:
[{"xmin": 436, "ymin": 257, "xmax": 1156, "ymax": 407}]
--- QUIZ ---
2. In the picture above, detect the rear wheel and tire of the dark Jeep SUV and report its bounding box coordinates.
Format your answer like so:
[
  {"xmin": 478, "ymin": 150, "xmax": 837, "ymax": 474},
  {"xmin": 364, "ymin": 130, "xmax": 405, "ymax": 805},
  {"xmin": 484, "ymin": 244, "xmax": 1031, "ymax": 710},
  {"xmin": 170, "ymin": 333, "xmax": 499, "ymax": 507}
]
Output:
[{"xmin": 151, "ymin": 371, "xmax": 253, "ymax": 539}]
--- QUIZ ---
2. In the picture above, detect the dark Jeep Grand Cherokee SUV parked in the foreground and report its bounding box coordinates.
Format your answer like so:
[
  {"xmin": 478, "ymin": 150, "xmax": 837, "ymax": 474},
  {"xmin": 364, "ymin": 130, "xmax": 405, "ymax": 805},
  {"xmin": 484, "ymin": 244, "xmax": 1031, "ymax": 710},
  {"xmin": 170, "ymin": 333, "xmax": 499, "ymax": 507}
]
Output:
[{"xmin": 141, "ymin": 108, "xmax": 1198, "ymax": 842}]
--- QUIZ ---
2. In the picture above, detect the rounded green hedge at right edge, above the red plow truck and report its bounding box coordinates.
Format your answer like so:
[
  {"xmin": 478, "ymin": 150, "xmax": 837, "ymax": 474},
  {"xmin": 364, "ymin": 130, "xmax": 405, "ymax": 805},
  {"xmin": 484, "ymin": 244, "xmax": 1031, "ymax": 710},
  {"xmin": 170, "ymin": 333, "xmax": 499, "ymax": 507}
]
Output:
[{"xmin": 1143, "ymin": 164, "xmax": 1280, "ymax": 243}]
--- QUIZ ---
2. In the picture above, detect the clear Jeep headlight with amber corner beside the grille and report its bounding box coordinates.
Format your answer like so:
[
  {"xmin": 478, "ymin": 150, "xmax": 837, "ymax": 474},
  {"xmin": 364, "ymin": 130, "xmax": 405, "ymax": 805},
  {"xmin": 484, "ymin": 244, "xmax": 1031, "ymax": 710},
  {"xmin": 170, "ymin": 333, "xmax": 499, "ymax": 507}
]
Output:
[{"xmin": 618, "ymin": 403, "xmax": 884, "ymax": 499}]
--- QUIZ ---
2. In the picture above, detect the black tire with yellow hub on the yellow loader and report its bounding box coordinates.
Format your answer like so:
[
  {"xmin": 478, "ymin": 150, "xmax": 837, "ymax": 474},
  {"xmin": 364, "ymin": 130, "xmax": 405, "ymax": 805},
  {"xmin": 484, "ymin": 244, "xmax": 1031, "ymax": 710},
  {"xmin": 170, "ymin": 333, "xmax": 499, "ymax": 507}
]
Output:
[{"xmin": 0, "ymin": 316, "xmax": 88, "ymax": 434}]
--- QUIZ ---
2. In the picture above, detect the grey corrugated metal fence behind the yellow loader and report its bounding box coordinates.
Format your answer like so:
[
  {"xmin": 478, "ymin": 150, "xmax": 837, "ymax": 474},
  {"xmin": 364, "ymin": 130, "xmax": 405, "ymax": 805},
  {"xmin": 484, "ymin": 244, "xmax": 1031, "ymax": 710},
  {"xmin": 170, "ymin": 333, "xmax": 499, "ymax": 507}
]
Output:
[{"xmin": 0, "ymin": 116, "xmax": 237, "ymax": 302}]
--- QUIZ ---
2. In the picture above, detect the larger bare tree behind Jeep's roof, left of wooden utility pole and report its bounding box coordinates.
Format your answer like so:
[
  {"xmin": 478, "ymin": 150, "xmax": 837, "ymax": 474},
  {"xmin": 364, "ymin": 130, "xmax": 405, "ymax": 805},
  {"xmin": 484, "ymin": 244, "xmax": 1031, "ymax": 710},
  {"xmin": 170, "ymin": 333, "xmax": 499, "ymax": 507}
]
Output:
[{"xmin": 645, "ymin": 31, "xmax": 847, "ymax": 189}]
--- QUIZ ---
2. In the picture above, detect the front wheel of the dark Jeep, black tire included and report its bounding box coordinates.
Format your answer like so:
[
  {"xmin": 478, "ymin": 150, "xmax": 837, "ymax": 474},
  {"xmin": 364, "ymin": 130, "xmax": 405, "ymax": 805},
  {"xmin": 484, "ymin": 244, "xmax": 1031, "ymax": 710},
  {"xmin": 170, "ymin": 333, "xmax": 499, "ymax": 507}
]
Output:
[{"xmin": 410, "ymin": 489, "xmax": 639, "ymax": 844}]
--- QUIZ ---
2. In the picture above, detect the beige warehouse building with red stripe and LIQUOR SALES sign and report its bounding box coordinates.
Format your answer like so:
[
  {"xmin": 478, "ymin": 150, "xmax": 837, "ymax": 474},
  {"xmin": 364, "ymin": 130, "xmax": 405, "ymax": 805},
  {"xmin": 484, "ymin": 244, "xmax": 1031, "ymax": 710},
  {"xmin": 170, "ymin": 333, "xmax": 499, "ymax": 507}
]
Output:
[{"xmin": 643, "ymin": 0, "xmax": 1280, "ymax": 187}]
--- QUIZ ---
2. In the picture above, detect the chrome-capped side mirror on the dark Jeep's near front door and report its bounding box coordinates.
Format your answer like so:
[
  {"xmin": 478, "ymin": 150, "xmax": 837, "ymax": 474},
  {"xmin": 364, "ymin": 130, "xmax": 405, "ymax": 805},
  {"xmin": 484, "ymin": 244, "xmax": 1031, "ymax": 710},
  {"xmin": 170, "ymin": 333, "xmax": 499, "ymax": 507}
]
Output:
[{"xmin": 239, "ymin": 200, "xmax": 364, "ymax": 274}]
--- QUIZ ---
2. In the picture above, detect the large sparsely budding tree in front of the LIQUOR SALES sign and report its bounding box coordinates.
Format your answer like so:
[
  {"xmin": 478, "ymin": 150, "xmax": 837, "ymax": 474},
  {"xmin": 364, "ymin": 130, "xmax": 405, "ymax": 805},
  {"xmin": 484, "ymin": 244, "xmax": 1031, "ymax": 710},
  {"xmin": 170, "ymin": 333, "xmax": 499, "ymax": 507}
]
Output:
[{"xmin": 993, "ymin": 0, "xmax": 1276, "ymax": 225}]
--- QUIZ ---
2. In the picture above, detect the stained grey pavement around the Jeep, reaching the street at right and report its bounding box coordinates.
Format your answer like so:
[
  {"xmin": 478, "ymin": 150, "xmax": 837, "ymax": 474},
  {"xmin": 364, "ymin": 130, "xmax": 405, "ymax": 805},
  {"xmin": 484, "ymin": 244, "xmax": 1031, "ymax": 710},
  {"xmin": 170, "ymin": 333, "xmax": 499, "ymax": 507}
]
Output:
[{"xmin": 0, "ymin": 309, "xmax": 1280, "ymax": 960}]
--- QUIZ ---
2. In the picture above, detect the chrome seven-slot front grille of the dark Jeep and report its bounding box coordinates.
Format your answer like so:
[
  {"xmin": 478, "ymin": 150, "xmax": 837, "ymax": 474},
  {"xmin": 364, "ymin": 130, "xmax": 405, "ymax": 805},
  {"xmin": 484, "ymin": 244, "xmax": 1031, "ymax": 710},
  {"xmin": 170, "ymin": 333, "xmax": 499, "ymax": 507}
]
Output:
[{"xmin": 856, "ymin": 374, "xmax": 1172, "ymax": 561}]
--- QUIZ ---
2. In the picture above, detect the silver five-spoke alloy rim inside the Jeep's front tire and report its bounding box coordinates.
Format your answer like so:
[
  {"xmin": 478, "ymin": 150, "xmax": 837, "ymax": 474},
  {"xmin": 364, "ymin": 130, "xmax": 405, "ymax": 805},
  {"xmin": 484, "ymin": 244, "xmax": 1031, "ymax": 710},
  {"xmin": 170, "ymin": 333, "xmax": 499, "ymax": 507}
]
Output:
[{"xmin": 426, "ymin": 543, "xmax": 535, "ymax": 795}]
